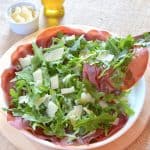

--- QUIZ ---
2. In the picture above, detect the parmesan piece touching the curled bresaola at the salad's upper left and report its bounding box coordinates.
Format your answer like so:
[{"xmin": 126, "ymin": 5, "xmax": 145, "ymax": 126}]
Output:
[{"xmin": 19, "ymin": 55, "xmax": 33, "ymax": 68}]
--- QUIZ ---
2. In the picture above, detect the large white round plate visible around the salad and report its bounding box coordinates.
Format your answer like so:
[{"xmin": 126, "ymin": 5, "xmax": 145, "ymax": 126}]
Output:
[{"xmin": 0, "ymin": 25, "xmax": 145, "ymax": 150}]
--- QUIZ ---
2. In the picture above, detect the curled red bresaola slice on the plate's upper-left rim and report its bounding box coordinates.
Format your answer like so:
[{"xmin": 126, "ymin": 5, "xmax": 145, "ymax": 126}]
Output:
[{"xmin": 11, "ymin": 44, "xmax": 33, "ymax": 65}]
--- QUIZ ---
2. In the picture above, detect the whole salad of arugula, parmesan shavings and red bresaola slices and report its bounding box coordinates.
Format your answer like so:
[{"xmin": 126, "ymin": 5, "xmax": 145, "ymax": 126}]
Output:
[{"xmin": 2, "ymin": 26, "xmax": 148, "ymax": 144}]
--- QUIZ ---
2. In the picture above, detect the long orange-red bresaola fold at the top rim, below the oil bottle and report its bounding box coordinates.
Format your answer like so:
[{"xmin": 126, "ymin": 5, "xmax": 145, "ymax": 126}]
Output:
[{"xmin": 36, "ymin": 26, "xmax": 85, "ymax": 48}]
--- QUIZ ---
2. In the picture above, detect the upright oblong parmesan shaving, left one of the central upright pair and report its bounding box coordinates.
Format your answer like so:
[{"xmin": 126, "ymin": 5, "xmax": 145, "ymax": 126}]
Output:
[{"xmin": 33, "ymin": 69, "xmax": 43, "ymax": 86}]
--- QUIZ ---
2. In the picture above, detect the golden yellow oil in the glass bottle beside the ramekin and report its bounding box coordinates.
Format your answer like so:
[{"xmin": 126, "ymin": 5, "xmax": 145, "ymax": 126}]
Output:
[{"xmin": 42, "ymin": 0, "xmax": 64, "ymax": 18}]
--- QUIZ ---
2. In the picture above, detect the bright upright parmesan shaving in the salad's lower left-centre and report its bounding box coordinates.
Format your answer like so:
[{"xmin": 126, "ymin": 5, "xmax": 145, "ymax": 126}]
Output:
[{"xmin": 47, "ymin": 101, "xmax": 58, "ymax": 118}]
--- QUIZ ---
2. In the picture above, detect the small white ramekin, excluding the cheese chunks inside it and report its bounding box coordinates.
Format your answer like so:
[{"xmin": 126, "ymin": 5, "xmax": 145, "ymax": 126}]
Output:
[{"xmin": 6, "ymin": 1, "xmax": 39, "ymax": 35}]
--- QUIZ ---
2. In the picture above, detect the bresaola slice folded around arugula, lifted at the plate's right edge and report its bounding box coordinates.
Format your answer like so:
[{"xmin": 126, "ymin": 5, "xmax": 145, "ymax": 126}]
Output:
[{"xmin": 83, "ymin": 48, "xmax": 149, "ymax": 93}]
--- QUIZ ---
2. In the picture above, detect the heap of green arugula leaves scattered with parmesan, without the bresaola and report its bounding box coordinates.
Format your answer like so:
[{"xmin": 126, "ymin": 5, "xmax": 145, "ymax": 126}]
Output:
[{"xmin": 9, "ymin": 33, "xmax": 134, "ymax": 143}]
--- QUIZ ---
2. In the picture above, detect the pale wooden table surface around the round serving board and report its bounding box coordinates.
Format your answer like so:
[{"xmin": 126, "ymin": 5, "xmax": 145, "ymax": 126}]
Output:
[{"xmin": 0, "ymin": 0, "xmax": 150, "ymax": 150}]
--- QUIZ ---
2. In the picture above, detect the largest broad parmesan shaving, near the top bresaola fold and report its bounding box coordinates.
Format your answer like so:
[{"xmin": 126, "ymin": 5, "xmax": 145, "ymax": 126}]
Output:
[{"xmin": 44, "ymin": 48, "xmax": 64, "ymax": 61}]
